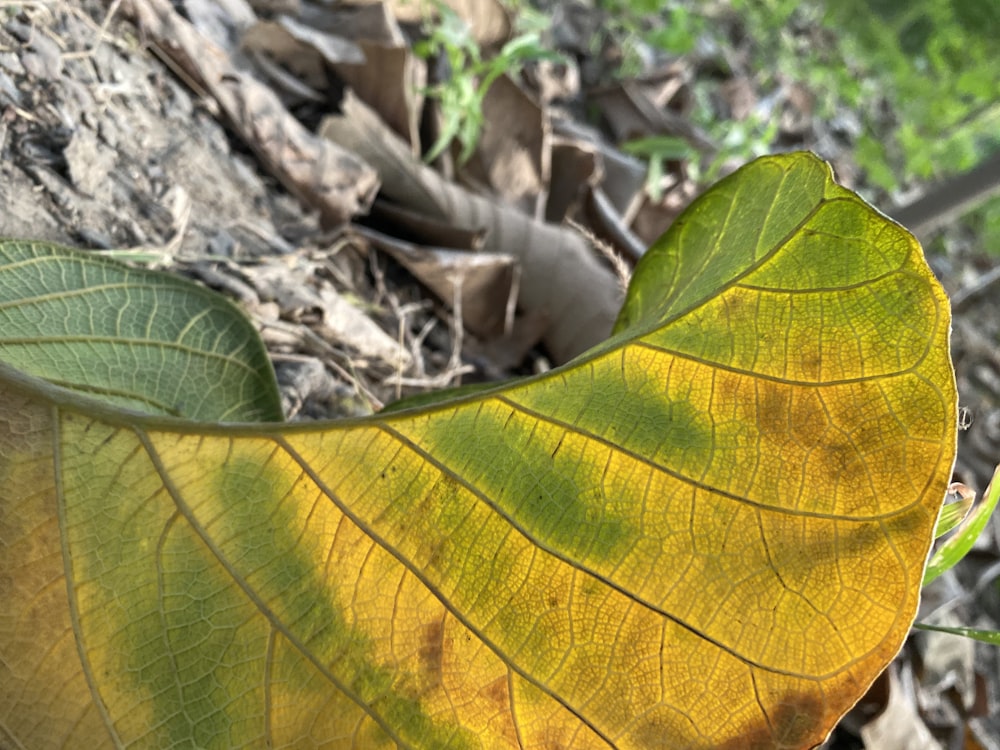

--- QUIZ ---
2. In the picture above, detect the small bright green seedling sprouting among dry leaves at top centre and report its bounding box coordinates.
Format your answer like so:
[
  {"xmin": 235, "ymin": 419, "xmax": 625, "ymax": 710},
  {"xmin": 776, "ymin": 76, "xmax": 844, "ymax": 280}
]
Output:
[{"xmin": 413, "ymin": 2, "xmax": 559, "ymax": 162}]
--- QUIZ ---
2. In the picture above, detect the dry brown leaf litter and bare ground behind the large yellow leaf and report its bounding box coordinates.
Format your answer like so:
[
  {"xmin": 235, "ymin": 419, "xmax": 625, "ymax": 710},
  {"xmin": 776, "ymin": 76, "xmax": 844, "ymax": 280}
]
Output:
[{"xmin": 0, "ymin": 0, "xmax": 1000, "ymax": 748}]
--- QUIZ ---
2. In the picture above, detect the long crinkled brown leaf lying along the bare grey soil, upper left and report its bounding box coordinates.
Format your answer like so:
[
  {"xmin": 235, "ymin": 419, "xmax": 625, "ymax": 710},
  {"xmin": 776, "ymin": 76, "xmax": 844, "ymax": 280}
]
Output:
[{"xmin": 124, "ymin": 0, "xmax": 378, "ymax": 224}]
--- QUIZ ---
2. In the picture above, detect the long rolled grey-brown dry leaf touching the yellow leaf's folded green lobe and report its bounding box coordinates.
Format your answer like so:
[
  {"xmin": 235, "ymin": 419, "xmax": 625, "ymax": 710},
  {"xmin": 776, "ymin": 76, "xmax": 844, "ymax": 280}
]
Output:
[{"xmin": 320, "ymin": 94, "xmax": 621, "ymax": 363}]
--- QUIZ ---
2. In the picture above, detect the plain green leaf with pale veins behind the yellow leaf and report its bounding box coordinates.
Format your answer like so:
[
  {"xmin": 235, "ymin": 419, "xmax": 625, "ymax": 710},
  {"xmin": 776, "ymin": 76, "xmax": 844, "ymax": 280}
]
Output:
[{"xmin": 0, "ymin": 242, "xmax": 282, "ymax": 422}]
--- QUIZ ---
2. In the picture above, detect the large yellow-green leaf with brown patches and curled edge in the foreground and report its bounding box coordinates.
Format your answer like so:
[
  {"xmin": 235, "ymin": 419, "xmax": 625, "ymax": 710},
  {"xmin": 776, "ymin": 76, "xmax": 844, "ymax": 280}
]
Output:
[{"xmin": 0, "ymin": 154, "xmax": 956, "ymax": 749}]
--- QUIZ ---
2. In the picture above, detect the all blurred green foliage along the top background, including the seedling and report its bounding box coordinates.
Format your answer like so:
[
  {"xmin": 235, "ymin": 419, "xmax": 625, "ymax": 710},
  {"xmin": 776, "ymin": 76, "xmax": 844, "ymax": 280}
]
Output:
[{"xmin": 417, "ymin": 0, "xmax": 1000, "ymax": 255}]
